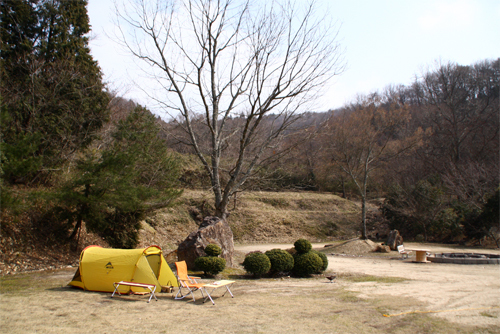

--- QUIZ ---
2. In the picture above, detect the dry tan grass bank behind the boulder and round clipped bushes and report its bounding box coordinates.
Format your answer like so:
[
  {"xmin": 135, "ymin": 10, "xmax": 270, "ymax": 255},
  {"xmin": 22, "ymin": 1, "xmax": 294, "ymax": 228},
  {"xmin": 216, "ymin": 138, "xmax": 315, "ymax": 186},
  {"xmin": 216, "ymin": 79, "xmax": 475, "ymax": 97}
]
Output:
[{"xmin": 140, "ymin": 190, "xmax": 360, "ymax": 250}]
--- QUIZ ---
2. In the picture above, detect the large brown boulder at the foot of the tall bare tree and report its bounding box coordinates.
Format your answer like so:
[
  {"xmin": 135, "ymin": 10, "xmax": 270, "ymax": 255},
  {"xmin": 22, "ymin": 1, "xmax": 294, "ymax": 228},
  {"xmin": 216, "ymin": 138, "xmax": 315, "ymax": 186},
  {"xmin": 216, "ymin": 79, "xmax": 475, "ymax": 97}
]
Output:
[{"xmin": 177, "ymin": 216, "xmax": 234, "ymax": 269}]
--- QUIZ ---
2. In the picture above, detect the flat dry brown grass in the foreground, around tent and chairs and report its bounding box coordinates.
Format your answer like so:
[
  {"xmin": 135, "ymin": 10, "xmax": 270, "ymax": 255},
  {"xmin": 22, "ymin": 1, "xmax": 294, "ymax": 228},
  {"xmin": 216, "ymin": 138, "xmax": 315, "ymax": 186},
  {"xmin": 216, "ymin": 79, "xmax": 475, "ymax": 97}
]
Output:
[{"xmin": 0, "ymin": 269, "xmax": 498, "ymax": 334}]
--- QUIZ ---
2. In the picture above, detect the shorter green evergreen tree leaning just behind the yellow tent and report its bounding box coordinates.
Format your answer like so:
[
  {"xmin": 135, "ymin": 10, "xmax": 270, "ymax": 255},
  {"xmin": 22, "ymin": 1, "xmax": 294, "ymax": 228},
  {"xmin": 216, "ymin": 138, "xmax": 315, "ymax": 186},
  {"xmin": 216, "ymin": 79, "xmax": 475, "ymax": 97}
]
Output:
[{"xmin": 55, "ymin": 106, "xmax": 182, "ymax": 248}]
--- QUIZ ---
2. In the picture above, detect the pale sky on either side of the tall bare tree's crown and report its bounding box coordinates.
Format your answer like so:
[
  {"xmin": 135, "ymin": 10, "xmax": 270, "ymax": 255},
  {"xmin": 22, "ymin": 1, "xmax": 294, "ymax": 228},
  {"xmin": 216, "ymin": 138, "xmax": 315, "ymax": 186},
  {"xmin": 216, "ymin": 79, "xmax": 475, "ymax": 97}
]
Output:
[{"xmin": 88, "ymin": 0, "xmax": 500, "ymax": 112}]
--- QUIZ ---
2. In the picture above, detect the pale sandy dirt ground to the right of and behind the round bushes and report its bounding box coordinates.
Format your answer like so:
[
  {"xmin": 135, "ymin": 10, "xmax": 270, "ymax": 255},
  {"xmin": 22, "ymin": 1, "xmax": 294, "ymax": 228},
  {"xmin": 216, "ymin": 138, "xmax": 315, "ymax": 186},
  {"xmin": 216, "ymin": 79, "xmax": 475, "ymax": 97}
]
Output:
[{"xmin": 235, "ymin": 243, "xmax": 500, "ymax": 325}]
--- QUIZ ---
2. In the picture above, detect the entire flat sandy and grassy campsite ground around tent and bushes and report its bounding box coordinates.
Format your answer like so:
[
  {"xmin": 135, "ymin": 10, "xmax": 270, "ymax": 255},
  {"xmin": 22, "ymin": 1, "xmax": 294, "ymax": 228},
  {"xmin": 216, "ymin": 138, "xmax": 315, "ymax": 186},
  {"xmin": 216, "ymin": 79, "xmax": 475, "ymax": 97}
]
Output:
[{"xmin": 0, "ymin": 243, "xmax": 500, "ymax": 334}]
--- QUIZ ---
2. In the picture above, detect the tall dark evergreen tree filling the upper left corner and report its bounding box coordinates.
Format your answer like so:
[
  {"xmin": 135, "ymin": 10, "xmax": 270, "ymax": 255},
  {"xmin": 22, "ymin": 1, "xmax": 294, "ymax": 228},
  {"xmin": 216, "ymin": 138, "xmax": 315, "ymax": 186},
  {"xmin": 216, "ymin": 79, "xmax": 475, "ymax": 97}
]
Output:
[{"xmin": 0, "ymin": 0, "xmax": 109, "ymax": 183}]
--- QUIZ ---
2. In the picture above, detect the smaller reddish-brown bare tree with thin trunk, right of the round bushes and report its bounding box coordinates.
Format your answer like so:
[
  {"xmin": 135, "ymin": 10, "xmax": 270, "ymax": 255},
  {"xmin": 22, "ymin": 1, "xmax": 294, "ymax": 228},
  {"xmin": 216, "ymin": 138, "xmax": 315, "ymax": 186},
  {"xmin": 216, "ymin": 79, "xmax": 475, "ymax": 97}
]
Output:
[{"xmin": 323, "ymin": 94, "xmax": 422, "ymax": 239}]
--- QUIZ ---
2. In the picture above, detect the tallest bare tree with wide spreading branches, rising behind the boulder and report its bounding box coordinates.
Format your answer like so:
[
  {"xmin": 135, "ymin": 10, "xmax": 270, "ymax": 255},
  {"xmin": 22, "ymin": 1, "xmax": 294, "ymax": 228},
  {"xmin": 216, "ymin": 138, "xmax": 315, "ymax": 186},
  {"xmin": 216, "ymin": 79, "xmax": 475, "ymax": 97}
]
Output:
[{"xmin": 117, "ymin": 0, "xmax": 343, "ymax": 218}]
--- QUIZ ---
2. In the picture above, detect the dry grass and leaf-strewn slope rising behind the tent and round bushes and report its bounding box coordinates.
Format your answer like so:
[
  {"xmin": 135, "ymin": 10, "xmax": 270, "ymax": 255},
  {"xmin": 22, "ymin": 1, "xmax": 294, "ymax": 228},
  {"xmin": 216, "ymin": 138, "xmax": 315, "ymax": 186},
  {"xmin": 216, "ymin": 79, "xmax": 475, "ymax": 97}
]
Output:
[{"xmin": 0, "ymin": 190, "xmax": 368, "ymax": 275}]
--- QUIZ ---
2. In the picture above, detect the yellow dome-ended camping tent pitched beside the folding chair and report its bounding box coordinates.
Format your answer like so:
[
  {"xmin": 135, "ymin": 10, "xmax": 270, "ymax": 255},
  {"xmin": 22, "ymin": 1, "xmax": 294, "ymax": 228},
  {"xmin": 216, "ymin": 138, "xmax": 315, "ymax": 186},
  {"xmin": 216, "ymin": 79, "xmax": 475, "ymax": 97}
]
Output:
[{"xmin": 69, "ymin": 246, "xmax": 178, "ymax": 293}]
